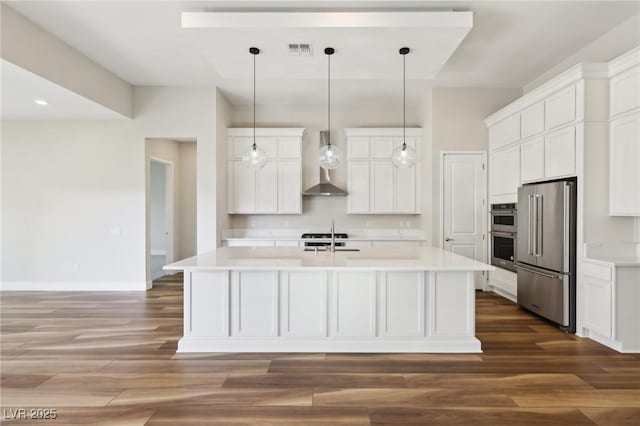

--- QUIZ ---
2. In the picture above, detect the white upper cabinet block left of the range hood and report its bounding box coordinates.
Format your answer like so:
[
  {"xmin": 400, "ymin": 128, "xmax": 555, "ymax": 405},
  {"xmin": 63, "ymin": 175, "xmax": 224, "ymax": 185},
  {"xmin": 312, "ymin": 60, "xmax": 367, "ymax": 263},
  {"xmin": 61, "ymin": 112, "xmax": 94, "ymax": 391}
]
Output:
[{"xmin": 227, "ymin": 128, "xmax": 304, "ymax": 214}]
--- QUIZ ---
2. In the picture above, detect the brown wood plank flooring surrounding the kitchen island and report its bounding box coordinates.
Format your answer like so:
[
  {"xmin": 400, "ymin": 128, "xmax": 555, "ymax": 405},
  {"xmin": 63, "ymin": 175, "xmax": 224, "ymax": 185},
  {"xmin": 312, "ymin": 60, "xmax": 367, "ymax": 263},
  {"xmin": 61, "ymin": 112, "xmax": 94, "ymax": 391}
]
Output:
[{"xmin": 0, "ymin": 276, "xmax": 640, "ymax": 426}]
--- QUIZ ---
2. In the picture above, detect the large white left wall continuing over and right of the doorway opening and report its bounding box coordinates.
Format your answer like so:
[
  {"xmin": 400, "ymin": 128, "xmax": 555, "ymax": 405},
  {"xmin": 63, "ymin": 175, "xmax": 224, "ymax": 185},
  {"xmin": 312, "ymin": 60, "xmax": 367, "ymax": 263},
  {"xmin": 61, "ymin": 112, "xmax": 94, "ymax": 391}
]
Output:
[{"xmin": 0, "ymin": 87, "xmax": 217, "ymax": 290}]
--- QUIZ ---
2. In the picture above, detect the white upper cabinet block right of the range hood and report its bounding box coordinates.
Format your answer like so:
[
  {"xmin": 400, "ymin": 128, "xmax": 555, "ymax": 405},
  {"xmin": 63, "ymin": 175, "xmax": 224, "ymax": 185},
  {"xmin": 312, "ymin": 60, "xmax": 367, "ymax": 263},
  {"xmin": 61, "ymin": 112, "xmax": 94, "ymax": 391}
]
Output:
[{"xmin": 345, "ymin": 128, "xmax": 422, "ymax": 214}]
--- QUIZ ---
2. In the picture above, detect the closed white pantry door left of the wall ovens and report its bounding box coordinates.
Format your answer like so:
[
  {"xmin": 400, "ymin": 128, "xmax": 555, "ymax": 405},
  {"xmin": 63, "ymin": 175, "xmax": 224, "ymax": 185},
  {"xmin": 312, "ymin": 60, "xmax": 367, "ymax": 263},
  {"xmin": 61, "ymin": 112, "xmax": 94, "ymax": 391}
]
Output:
[{"xmin": 441, "ymin": 153, "xmax": 486, "ymax": 288}]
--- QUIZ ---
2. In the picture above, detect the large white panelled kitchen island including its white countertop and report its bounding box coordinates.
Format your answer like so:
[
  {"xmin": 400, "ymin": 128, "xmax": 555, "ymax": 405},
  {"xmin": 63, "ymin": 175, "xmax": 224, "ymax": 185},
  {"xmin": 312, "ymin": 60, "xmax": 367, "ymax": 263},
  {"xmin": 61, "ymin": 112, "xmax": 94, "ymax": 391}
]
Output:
[{"xmin": 165, "ymin": 247, "xmax": 493, "ymax": 352}]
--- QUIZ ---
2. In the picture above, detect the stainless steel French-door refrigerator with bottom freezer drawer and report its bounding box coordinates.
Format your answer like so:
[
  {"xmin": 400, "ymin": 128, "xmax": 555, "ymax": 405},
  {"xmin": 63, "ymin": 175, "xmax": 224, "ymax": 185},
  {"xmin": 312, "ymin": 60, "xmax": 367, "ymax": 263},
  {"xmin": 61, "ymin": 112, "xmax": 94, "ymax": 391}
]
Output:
[{"xmin": 516, "ymin": 179, "xmax": 576, "ymax": 333}]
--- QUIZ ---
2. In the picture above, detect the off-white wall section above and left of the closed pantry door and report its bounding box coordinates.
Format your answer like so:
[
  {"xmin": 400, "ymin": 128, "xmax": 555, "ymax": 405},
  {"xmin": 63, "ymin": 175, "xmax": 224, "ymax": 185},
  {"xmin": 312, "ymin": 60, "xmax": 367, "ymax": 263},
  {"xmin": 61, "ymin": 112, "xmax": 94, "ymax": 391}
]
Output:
[{"xmin": 424, "ymin": 87, "xmax": 522, "ymax": 245}]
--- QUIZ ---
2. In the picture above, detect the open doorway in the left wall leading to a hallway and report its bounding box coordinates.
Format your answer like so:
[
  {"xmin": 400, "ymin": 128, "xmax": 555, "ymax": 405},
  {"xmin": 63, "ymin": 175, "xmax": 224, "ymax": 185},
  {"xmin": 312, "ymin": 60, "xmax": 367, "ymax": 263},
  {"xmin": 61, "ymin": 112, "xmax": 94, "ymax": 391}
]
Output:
[{"xmin": 145, "ymin": 138, "xmax": 197, "ymax": 288}]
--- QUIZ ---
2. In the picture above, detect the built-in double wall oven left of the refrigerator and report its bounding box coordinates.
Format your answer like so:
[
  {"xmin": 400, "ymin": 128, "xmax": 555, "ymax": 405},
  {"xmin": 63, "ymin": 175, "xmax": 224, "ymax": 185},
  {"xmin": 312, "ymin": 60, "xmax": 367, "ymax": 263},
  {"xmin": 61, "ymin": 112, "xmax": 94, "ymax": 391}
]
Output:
[{"xmin": 490, "ymin": 203, "xmax": 518, "ymax": 272}]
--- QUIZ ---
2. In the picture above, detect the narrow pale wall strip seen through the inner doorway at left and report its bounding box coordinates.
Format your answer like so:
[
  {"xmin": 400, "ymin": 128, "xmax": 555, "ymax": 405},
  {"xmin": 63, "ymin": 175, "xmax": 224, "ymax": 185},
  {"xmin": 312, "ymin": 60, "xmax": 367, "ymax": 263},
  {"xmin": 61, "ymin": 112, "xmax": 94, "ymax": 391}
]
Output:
[{"xmin": 149, "ymin": 161, "xmax": 169, "ymax": 255}]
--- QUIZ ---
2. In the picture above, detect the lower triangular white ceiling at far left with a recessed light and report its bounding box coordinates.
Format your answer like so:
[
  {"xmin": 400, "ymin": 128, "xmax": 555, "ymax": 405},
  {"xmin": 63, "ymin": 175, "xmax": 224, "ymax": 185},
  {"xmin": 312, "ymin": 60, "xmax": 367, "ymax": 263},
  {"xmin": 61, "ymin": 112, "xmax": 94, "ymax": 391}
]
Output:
[{"xmin": 0, "ymin": 59, "xmax": 124, "ymax": 120}]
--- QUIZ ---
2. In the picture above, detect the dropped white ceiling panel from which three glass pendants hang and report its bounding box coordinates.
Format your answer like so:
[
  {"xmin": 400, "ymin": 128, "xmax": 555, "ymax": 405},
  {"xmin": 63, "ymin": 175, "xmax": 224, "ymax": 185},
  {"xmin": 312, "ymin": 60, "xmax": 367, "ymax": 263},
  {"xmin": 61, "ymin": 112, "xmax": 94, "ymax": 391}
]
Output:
[{"xmin": 182, "ymin": 11, "xmax": 473, "ymax": 80}]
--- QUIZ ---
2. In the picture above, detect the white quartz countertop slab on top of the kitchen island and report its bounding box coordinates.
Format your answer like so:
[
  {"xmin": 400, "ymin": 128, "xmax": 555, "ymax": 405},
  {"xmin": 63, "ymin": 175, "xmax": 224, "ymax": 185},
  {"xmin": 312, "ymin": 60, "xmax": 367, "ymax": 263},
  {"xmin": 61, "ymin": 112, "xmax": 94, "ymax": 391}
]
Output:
[{"xmin": 164, "ymin": 247, "xmax": 495, "ymax": 272}]
